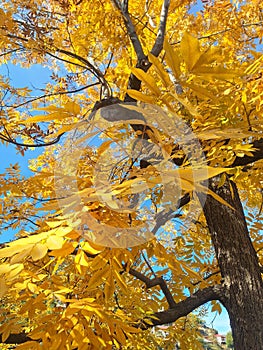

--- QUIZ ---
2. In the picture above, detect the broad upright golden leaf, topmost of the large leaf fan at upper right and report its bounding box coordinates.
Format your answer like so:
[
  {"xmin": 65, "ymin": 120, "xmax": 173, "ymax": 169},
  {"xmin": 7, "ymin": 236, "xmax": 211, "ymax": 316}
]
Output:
[{"xmin": 180, "ymin": 32, "xmax": 201, "ymax": 71}]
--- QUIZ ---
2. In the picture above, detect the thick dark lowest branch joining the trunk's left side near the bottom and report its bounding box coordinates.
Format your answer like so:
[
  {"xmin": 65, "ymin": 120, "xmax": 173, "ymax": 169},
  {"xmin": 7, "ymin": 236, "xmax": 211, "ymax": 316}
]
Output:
[{"xmin": 137, "ymin": 285, "xmax": 224, "ymax": 330}]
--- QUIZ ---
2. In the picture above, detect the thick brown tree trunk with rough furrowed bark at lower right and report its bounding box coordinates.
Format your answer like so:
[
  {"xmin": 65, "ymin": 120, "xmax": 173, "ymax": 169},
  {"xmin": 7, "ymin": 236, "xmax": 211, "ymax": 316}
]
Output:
[{"xmin": 204, "ymin": 178, "xmax": 263, "ymax": 350}]
